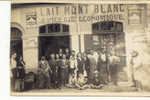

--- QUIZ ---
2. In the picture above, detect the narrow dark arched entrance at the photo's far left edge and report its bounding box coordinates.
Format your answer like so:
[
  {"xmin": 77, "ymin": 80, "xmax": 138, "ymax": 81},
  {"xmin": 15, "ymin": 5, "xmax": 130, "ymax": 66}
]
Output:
[{"xmin": 10, "ymin": 27, "xmax": 23, "ymax": 57}]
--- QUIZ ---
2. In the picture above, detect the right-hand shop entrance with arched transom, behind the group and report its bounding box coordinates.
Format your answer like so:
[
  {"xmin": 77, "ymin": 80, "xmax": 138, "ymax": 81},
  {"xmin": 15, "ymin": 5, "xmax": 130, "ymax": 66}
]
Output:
[{"xmin": 85, "ymin": 21, "xmax": 128, "ymax": 81}]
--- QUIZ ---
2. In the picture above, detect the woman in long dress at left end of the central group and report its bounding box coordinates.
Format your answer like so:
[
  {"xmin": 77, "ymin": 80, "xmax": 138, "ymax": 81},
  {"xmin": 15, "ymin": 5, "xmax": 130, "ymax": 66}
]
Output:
[{"xmin": 38, "ymin": 56, "xmax": 52, "ymax": 88}]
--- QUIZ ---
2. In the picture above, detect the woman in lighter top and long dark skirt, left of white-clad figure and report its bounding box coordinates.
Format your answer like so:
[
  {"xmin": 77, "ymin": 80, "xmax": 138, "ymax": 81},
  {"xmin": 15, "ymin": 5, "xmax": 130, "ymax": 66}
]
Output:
[{"xmin": 60, "ymin": 54, "xmax": 69, "ymax": 87}]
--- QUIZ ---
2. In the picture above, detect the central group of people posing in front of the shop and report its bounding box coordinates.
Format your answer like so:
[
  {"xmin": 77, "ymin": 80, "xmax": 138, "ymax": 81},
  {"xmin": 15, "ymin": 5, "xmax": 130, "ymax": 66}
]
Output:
[{"xmin": 37, "ymin": 48, "xmax": 120, "ymax": 89}]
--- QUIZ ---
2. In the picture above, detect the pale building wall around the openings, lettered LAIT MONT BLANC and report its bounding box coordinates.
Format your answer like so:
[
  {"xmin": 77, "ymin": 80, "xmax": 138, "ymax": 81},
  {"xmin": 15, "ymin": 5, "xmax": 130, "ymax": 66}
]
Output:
[{"xmin": 11, "ymin": 4, "xmax": 150, "ymax": 83}]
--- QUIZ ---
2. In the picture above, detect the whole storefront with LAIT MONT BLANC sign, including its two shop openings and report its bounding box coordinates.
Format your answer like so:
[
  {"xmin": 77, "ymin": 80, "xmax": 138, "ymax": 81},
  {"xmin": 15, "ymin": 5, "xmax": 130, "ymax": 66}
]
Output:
[{"xmin": 11, "ymin": 3, "xmax": 150, "ymax": 82}]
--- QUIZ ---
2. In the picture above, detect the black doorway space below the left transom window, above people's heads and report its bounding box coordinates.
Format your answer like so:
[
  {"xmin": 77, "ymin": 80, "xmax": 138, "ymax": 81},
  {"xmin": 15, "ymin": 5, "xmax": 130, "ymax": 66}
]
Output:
[{"xmin": 39, "ymin": 36, "xmax": 70, "ymax": 59}]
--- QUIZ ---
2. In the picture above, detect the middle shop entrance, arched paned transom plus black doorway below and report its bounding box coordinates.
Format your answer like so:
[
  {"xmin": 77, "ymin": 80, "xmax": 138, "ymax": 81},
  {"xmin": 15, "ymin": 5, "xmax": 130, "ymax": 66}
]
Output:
[{"xmin": 39, "ymin": 24, "xmax": 70, "ymax": 59}]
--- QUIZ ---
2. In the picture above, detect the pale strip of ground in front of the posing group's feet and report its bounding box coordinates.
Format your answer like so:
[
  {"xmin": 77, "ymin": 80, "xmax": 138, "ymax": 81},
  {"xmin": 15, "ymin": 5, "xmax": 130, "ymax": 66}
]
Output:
[{"xmin": 12, "ymin": 85, "xmax": 137, "ymax": 96}]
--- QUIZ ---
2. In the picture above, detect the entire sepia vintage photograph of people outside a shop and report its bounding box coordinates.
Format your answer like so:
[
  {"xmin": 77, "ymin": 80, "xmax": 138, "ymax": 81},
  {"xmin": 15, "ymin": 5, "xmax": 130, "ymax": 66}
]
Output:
[{"xmin": 10, "ymin": 2, "xmax": 150, "ymax": 96}]
